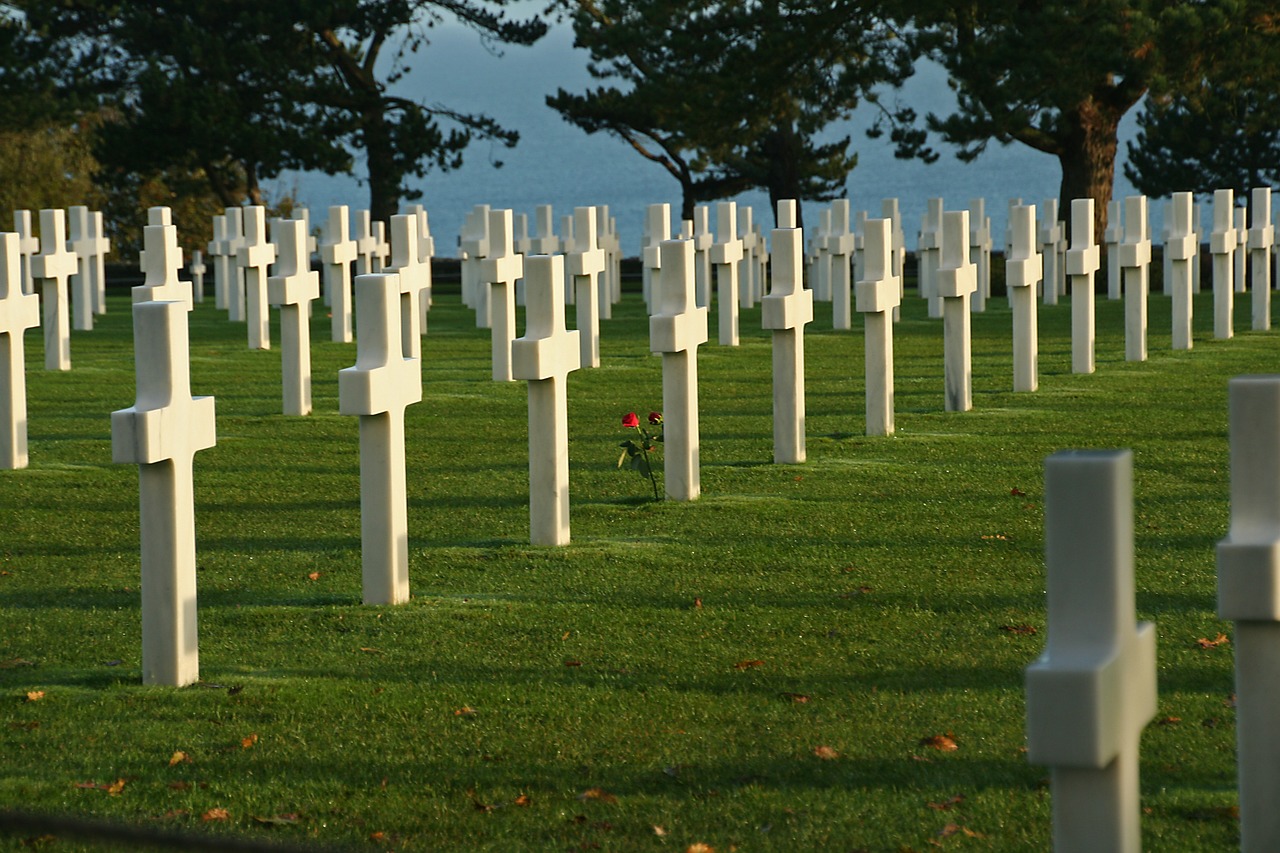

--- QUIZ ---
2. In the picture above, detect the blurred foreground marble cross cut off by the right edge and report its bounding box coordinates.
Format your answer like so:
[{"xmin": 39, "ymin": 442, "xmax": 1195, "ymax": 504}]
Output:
[{"xmin": 1217, "ymin": 373, "xmax": 1280, "ymax": 853}]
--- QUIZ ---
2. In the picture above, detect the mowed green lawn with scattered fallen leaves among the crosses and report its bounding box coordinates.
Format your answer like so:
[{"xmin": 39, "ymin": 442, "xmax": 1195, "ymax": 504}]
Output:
[{"xmin": 0, "ymin": 274, "xmax": 1259, "ymax": 850}]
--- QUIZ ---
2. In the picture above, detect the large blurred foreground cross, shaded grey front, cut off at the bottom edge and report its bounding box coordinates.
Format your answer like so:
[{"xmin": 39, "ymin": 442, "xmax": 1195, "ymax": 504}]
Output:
[{"xmin": 1027, "ymin": 451, "xmax": 1156, "ymax": 853}]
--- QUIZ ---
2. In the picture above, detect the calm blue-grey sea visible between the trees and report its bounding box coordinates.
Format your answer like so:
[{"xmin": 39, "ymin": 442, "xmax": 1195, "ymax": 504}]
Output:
[{"xmin": 285, "ymin": 17, "xmax": 1160, "ymax": 255}]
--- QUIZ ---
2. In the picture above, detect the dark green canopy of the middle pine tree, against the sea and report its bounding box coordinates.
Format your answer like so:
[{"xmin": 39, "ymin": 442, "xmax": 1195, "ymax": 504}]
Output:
[{"xmin": 548, "ymin": 0, "xmax": 911, "ymax": 219}]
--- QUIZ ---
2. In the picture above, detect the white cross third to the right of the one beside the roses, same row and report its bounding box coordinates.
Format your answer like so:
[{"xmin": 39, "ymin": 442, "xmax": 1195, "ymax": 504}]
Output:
[{"xmin": 936, "ymin": 210, "xmax": 978, "ymax": 411}]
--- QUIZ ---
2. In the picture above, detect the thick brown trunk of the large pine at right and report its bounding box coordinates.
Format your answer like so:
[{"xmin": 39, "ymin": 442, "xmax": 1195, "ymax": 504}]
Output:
[{"xmin": 1057, "ymin": 99, "xmax": 1124, "ymax": 243}]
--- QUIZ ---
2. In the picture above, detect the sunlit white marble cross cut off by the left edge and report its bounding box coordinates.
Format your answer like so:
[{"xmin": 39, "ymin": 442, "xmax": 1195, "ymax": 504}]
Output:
[{"xmin": 0, "ymin": 233, "xmax": 40, "ymax": 469}]
